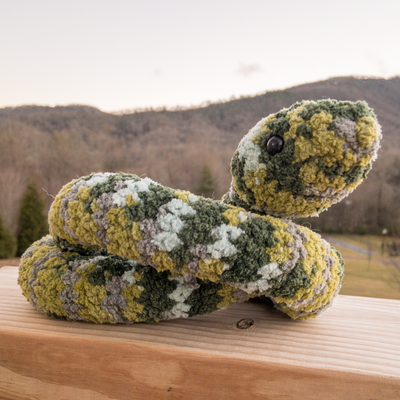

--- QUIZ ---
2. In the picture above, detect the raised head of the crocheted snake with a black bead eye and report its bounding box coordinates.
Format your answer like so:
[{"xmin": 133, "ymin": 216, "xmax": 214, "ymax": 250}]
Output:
[{"xmin": 223, "ymin": 100, "xmax": 381, "ymax": 218}]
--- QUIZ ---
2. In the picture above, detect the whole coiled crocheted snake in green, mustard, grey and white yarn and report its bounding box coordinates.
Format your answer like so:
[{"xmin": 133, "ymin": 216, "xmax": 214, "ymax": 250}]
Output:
[{"xmin": 19, "ymin": 100, "xmax": 381, "ymax": 324}]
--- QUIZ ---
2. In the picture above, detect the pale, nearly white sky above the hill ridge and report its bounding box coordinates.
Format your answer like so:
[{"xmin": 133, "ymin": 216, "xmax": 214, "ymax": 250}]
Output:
[{"xmin": 0, "ymin": 0, "xmax": 400, "ymax": 112}]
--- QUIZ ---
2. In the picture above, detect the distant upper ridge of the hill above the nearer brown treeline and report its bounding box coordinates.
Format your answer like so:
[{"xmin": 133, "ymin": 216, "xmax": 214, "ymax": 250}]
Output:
[{"xmin": 0, "ymin": 77, "xmax": 400, "ymax": 145}]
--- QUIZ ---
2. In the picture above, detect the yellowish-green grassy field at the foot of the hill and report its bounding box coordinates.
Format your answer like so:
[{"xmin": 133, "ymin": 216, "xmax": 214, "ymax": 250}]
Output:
[{"xmin": 0, "ymin": 235, "xmax": 400, "ymax": 300}]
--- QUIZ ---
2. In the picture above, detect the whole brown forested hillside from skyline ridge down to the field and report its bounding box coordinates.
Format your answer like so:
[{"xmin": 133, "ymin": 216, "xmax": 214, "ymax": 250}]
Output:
[{"xmin": 0, "ymin": 77, "xmax": 400, "ymax": 234}]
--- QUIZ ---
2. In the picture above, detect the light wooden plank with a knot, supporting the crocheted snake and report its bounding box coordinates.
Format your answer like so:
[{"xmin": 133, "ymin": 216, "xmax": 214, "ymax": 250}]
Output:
[{"xmin": 0, "ymin": 267, "xmax": 400, "ymax": 400}]
